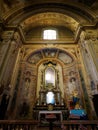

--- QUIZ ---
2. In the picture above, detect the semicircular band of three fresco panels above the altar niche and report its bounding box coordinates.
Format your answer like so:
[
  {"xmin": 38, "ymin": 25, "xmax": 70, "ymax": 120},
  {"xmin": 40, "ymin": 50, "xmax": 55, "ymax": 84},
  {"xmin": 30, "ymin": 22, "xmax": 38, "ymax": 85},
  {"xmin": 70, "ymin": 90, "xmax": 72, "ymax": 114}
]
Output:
[{"xmin": 27, "ymin": 48, "xmax": 73, "ymax": 65}]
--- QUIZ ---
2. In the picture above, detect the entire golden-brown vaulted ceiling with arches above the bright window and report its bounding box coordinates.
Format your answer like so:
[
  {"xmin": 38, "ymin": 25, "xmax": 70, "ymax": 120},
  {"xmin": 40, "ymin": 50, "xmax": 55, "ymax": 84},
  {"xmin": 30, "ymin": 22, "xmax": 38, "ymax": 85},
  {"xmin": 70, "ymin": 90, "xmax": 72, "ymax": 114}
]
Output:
[{"xmin": 1, "ymin": 0, "xmax": 98, "ymax": 42}]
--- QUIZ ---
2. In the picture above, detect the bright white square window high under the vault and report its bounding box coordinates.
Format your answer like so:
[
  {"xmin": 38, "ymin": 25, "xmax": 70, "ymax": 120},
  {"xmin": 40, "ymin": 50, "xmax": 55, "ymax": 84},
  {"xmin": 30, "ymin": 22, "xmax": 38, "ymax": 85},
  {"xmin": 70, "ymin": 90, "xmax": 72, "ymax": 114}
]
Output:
[{"xmin": 43, "ymin": 29, "xmax": 56, "ymax": 40}]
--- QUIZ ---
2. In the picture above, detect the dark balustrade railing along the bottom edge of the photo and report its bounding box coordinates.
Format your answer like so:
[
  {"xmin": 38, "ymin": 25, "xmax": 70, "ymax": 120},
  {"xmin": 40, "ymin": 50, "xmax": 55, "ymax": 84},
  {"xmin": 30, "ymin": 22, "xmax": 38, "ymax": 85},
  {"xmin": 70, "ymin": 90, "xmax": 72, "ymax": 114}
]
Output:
[{"xmin": 0, "ymin": 120, "xmax": 98, "ymax": 130}]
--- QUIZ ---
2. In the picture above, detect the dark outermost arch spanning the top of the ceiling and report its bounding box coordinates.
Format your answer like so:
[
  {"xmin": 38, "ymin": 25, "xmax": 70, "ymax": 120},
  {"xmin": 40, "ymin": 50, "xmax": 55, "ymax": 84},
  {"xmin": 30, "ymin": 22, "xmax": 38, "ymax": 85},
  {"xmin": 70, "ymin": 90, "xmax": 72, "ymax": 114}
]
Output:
[{"xmin": 3, "ymin": 1, "xmax": 95, "ymax": 21}]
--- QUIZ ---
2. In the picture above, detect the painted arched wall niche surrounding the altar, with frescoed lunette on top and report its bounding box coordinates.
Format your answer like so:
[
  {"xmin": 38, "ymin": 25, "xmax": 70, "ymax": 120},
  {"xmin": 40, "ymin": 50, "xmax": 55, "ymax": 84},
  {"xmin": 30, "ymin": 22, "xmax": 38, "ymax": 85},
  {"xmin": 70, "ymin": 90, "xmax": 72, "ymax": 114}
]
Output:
[{"xmin": 12, "ymin": 48, "xmax": 83, "ymax": 119}]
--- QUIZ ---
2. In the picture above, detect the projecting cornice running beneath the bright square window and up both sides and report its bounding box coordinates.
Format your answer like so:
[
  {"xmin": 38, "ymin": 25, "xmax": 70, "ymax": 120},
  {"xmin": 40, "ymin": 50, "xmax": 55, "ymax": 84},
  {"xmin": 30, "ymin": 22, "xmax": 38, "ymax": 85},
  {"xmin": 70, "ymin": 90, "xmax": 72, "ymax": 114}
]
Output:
[{"xmin": 5, "ymin": 22, "xmax": 98, "ymax": 46}]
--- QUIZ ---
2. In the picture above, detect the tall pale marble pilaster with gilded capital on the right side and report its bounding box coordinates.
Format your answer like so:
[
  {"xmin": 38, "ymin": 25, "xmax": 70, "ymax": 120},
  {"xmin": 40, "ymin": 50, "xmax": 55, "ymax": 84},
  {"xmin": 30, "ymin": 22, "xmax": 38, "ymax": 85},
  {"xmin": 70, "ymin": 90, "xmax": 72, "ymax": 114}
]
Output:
[{"xmin": 79, "ymin": 29, "xmax": 98, "ymax": 118}]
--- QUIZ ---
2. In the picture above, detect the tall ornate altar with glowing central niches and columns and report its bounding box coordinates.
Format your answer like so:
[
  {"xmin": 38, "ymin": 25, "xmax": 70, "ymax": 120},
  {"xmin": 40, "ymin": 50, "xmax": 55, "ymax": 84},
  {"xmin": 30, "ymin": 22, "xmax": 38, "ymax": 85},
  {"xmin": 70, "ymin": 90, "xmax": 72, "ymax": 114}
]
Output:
[{"xmin": 33, "ymin": 62, "xmax": 68, "ymax": 122}]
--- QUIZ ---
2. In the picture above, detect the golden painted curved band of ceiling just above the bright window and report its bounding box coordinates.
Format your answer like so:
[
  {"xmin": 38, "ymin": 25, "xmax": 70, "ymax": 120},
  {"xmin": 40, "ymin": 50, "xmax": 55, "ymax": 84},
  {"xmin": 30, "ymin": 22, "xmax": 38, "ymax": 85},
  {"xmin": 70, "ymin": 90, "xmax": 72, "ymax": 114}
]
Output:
[{"xmin": 21, "ymin": 12, "xmax": 79, "ymax": 32}]
